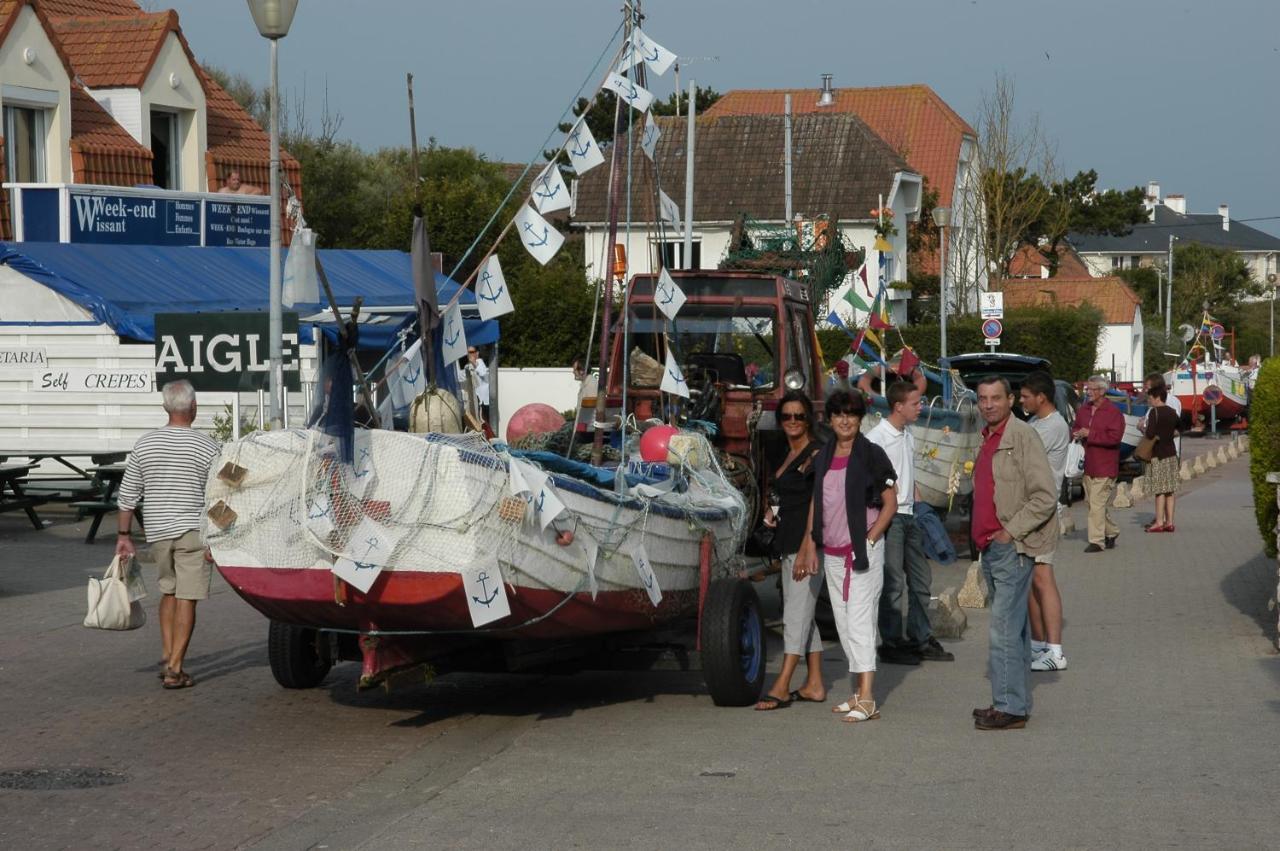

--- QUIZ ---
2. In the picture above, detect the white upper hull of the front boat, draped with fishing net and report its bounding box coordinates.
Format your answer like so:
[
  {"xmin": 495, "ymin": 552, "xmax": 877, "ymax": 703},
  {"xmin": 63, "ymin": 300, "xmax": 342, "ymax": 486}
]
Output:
[{"xmin": 205, "ymin": 430, "xmax": 746, "ymax": 591}]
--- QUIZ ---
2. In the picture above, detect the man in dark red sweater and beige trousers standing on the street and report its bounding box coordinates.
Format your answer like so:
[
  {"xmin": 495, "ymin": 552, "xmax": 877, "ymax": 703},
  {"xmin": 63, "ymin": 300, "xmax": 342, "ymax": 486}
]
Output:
[{"xmin": 1071, "ymin": 375, "xmax": 1124, "ymax": 553}]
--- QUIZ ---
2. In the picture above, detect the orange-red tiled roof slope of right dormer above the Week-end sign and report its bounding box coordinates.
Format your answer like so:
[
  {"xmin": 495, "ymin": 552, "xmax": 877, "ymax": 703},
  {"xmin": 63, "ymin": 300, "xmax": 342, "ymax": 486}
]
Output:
[{"xmin": 50, "ymin": 10, "xmax": 178, "ymax": 88}]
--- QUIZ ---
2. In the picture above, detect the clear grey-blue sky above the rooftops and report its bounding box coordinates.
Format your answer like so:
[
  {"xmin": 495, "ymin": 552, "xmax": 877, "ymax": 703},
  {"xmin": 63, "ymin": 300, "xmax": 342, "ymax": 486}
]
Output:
[{"xmin": 172, "ymin": 0, "xmax": 1280, "ymax": 234}]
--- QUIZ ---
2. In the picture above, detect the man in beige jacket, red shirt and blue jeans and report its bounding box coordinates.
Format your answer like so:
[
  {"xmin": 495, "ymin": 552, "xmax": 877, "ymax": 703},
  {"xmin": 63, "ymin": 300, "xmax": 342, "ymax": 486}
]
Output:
[{"xmin": 972, "ymin": 376, "xmax": 1057, "ymax": 729}]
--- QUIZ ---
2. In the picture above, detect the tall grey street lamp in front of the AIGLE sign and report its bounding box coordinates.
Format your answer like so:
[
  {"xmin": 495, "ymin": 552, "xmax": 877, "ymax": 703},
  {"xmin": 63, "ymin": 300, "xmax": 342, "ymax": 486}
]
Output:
[{"xmin": 247, "ymin": 0, "xmax": 298, "ymax": 429}]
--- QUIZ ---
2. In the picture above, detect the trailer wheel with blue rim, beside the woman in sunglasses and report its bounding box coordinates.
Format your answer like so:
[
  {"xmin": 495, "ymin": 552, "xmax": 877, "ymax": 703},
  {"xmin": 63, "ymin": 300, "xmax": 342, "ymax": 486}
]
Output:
[{"xmin": 703, "ymin": 578, "xmax": 764, "ymax": 706}]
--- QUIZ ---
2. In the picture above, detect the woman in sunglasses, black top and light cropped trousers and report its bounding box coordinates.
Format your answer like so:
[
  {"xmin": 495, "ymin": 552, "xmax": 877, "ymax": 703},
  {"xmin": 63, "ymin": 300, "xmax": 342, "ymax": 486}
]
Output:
[{"xmin": 755, "ymin": 390, "xmax": 827, "ymax": 712}]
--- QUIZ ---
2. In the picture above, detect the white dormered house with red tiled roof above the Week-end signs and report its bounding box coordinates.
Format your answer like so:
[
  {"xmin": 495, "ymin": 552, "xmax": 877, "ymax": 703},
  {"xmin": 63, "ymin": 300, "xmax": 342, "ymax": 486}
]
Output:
[{"xmin": 0, "ymin": 0, "xmax": 302, "ymax": 238}]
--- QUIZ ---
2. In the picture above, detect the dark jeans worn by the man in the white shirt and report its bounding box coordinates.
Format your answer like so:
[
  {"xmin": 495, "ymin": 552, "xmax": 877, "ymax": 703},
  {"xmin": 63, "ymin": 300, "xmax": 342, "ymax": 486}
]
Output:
[{"xmin": 879, "ymin": 514, "xmax": 933, "ymax": 650}]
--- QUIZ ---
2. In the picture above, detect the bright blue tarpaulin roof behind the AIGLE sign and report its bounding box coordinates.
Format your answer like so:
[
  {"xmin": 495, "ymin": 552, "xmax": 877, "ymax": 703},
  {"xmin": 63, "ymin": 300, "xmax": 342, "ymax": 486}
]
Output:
[{"xmin": 0, "ymin": 242, "xmax": 498, "ymax": 351}]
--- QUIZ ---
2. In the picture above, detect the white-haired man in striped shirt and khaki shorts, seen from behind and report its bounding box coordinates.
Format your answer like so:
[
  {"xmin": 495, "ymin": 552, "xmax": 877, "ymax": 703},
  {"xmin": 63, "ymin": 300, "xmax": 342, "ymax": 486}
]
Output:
[{"xmin": 115, "ymin": 380, "xmax": 220, "ymax": 688}]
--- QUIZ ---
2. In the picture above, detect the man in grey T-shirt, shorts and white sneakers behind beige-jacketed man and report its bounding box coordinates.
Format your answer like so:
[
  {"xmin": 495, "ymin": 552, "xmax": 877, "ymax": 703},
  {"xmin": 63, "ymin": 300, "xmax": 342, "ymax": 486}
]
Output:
[{"xmin": 1020, "ymin": 371, "xmax": 1071, "ymax": 671}]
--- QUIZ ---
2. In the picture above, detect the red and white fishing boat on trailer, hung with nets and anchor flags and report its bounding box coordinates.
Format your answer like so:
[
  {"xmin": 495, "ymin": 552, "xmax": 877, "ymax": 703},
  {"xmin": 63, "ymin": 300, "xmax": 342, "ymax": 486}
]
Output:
[{"xmin": 206, "ymin": 9, "xmax": 773, "ymax": 705}]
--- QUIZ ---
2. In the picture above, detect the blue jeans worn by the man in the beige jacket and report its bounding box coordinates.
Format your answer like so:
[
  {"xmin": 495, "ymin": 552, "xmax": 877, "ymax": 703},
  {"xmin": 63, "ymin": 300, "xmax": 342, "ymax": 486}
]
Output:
[{"xmin": 982, "ymin": 541, "xmax": 1034, "ymax": 715}]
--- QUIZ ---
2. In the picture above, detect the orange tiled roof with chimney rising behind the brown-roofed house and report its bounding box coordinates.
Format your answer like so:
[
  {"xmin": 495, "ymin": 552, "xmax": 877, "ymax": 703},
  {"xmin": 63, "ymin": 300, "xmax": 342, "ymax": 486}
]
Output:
[{"xmin": 705, "ymin": 83, "xmax": 978, "ymax": 206}]
